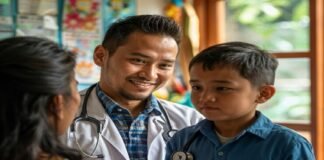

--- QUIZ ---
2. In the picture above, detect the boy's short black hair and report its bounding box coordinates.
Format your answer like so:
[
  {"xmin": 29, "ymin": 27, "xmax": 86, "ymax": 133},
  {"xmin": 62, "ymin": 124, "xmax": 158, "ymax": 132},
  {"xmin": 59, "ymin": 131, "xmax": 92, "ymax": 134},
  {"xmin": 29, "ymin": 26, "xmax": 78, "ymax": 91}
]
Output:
[{"xmin": 189, "ymin": 42, "xmax": 278, "ymax": 86}]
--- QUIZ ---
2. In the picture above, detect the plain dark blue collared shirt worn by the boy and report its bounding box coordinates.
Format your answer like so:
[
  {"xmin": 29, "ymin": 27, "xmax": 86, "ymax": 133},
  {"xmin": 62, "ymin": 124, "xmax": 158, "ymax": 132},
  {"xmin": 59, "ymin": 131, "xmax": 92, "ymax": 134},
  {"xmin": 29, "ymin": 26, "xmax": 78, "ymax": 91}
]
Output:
[{"xmin": 165, "ymin": 111, "xmax": 315, "ymax": 160}]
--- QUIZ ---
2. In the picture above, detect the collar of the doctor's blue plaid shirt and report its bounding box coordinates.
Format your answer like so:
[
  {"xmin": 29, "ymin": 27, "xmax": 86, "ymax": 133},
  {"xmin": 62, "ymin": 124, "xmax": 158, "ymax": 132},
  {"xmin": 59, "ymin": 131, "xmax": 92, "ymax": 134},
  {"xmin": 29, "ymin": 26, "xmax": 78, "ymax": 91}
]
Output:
[{"xmin": 96, "ymin": 84, "xmax": 161, "ymax": 115}]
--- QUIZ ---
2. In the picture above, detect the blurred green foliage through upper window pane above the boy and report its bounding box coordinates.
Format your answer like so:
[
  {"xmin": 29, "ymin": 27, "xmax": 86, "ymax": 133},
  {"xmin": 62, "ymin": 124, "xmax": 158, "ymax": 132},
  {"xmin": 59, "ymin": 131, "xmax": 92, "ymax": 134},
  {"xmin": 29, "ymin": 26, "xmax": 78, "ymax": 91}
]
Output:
[{"xmin": 226, "ymin": 0, "xmax": 309, "ymax": 51}]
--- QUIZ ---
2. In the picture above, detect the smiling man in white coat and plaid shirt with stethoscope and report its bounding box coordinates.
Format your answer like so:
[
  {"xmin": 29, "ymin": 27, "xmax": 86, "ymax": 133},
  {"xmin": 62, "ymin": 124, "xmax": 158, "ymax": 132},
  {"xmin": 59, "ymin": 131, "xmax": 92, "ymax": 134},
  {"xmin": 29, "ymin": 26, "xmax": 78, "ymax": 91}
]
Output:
[{"xmin": 66, "ymin": 15, "xmax": 202, "ymax": 160}]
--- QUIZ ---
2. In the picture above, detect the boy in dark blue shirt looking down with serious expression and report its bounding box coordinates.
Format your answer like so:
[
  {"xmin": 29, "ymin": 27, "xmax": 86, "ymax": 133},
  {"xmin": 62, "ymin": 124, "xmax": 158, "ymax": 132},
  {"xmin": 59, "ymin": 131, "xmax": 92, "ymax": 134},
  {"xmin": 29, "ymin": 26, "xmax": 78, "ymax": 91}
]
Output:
[{"xmin": 166, "ymin": 42, "xmax": 315, "ymax": 160}]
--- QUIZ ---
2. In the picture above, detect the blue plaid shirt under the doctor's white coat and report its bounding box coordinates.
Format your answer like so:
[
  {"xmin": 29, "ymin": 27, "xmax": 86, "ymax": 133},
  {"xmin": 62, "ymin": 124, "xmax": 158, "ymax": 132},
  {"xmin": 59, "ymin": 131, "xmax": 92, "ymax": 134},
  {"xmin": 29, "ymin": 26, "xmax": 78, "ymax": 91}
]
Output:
[{"xmin": 96, "ymin": 85, "xmax": 161, "ymax": 160}]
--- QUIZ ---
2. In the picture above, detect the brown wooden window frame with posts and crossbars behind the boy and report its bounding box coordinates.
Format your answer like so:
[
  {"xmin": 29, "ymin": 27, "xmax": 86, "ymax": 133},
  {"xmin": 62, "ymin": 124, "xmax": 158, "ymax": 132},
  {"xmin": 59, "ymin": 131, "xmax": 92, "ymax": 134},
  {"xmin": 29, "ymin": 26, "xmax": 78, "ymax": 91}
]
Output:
[{"xmin": 193, "ymin": 0, "xmax": 324, "ymax": 160}]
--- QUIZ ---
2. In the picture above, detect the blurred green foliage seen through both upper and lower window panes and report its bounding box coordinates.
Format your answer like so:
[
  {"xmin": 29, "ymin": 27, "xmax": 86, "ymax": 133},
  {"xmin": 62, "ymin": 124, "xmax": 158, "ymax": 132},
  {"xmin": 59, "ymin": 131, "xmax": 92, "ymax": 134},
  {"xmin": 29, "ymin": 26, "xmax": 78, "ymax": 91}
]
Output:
[{"xmin": 226, "ymin": 0, "xmax": 310, "ymax": 122}]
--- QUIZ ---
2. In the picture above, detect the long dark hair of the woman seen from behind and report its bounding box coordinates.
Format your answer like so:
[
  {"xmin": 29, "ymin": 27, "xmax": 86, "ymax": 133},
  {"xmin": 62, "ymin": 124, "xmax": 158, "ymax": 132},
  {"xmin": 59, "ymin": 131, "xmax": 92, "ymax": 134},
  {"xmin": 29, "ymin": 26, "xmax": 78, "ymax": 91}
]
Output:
[{"xmin": 0, "ymin": 37, "xmax": 81, "ymax": 160}]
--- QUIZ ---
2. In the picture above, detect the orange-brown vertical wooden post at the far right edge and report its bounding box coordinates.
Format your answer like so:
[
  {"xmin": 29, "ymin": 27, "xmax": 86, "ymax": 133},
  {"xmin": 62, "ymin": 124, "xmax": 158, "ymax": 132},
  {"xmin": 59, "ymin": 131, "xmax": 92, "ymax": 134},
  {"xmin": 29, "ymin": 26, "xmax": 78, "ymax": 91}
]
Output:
[{"xmin": 310, "ymin": 0, "xmax": 324, "ymax": 160}]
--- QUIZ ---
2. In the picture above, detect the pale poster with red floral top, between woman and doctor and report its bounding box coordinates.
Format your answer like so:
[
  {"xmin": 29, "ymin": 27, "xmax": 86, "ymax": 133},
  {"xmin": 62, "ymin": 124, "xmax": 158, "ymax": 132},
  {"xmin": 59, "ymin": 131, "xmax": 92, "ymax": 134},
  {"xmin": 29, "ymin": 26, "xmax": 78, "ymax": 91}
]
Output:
[{"xmin": 62, "ymin": 0, "xmax": 101, "ymax": 84}]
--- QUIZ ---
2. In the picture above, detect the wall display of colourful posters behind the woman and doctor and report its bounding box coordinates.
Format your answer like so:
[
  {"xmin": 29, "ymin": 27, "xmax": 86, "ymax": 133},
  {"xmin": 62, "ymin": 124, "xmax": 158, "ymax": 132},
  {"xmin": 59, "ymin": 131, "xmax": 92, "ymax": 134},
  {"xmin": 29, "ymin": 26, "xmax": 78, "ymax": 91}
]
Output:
[{"xmin": 0, "ymin": 0, "xmax": 136, "ymax": 89}]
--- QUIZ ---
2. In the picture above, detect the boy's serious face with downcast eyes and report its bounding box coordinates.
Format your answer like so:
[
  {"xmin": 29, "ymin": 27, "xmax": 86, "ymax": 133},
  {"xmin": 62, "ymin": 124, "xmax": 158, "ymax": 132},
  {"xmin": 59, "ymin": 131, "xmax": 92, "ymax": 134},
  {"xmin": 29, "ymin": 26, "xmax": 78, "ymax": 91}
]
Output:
[{"xmin": 190, "ymin": 63, "xmax": 260, "ymax": 123}]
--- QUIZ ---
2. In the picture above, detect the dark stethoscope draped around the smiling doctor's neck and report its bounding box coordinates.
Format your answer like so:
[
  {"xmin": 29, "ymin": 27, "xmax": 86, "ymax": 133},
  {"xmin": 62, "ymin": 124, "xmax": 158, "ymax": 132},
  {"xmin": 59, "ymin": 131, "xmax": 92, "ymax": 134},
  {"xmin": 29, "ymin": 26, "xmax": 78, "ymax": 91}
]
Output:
[{"xmin": 70, "ymin": 83, "xmax": 178, "ymax": 158}]
